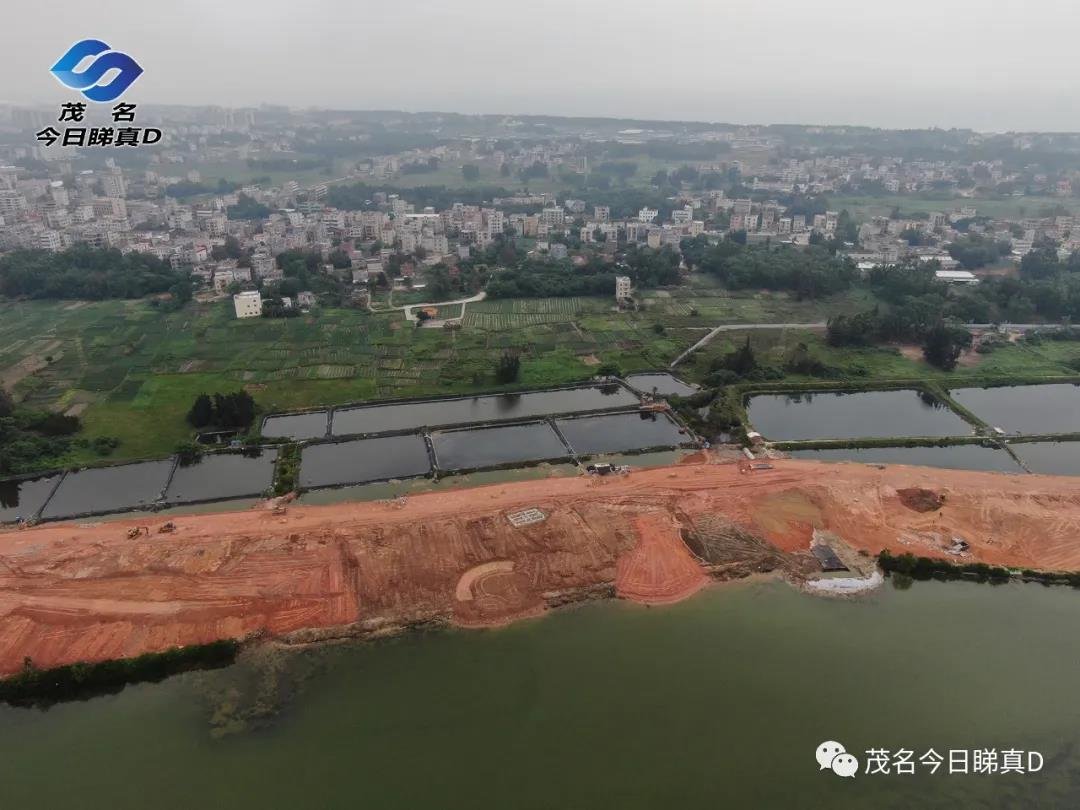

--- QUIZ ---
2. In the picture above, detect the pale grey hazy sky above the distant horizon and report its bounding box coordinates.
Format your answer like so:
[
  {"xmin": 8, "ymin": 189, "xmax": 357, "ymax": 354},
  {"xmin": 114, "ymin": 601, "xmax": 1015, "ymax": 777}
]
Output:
[{"xmin": 0, "ymin": 0, "xmax": 1080, "ymax": 131}]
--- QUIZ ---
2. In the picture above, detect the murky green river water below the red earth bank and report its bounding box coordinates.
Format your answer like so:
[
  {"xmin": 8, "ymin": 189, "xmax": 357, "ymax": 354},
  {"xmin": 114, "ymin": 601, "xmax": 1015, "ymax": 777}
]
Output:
[{"xmin": 0, "ymin": 581, "xmax": 1080, "ymax": 810}]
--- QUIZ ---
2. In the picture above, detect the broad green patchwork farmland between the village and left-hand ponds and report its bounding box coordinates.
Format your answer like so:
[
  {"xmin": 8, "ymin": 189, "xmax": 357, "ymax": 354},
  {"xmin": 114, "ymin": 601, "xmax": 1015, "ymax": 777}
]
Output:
[{"xmin": 0, "ymin": 285, "xmax": 865, "ymax": 462}]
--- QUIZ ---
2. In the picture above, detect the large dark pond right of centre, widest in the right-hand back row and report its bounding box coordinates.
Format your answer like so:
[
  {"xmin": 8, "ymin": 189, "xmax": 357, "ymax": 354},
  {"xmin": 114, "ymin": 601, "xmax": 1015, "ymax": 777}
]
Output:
[{"xmin": 746, "ymin": 391, "xmax": 972, "ymax": 441}]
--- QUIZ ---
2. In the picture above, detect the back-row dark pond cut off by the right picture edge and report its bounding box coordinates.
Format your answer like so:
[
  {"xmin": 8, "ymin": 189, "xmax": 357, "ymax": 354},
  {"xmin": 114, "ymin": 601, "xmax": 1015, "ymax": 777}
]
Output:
[{"xmin": 951, "ymin": 384, "xmax": 1080, "ymax": 433}]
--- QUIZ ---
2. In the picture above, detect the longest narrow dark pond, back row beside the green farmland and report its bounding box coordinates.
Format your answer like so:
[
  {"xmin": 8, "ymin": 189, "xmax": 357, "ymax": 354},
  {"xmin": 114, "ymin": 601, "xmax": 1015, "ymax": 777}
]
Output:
[{"xmin": 334, "ymin": 386, "xmax": 638, "ymax": 436}]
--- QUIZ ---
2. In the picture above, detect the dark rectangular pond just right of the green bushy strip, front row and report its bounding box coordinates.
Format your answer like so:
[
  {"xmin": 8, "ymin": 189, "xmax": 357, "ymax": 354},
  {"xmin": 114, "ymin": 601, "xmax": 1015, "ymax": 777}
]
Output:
[{"xmin": 300, "ymin": 434, "xmax": 431, "ymax": 487}]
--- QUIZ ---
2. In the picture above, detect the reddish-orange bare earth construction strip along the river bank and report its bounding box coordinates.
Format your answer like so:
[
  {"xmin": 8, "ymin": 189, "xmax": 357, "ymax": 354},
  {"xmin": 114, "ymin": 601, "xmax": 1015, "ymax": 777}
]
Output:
[{"xmin": 0, "ymin": 455, "xmax": 1080, "ymax": 673}]
